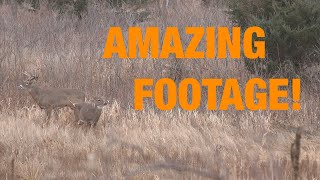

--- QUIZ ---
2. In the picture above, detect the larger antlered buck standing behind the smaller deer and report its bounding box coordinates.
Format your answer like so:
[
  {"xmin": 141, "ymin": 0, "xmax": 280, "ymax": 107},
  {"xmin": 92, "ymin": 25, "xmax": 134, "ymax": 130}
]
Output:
[{"xmin": 19, "ymin": 72, "xmax": 85, "ymax": 122}]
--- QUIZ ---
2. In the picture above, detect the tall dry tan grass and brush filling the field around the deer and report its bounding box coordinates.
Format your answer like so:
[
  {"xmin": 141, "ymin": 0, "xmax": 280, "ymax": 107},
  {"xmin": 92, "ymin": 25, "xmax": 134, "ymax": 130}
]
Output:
[{"xmin": 0, "ymin": 1, "xmax": 320, "ymax": 179}]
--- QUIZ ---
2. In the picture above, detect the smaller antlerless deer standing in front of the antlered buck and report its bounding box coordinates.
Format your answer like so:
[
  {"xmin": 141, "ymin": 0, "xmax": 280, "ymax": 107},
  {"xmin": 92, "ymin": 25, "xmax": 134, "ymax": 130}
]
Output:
[{"xmin": 69, "ymin": 97, "xmax": 108, "ymax": 128}]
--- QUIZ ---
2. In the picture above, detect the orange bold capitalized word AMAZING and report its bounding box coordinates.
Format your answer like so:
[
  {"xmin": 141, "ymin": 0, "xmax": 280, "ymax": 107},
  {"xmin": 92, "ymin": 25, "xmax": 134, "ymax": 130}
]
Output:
[{"xmin": 103, "ymin": 26, "xmax": 265, "ymax": 59}]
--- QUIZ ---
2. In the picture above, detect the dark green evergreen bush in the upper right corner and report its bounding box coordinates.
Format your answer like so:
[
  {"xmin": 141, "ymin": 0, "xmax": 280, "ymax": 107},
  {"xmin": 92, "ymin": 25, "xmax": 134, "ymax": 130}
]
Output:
[{"xmin": 230, "ymin": 0, "xmax": 320, "ymax": 76}]
